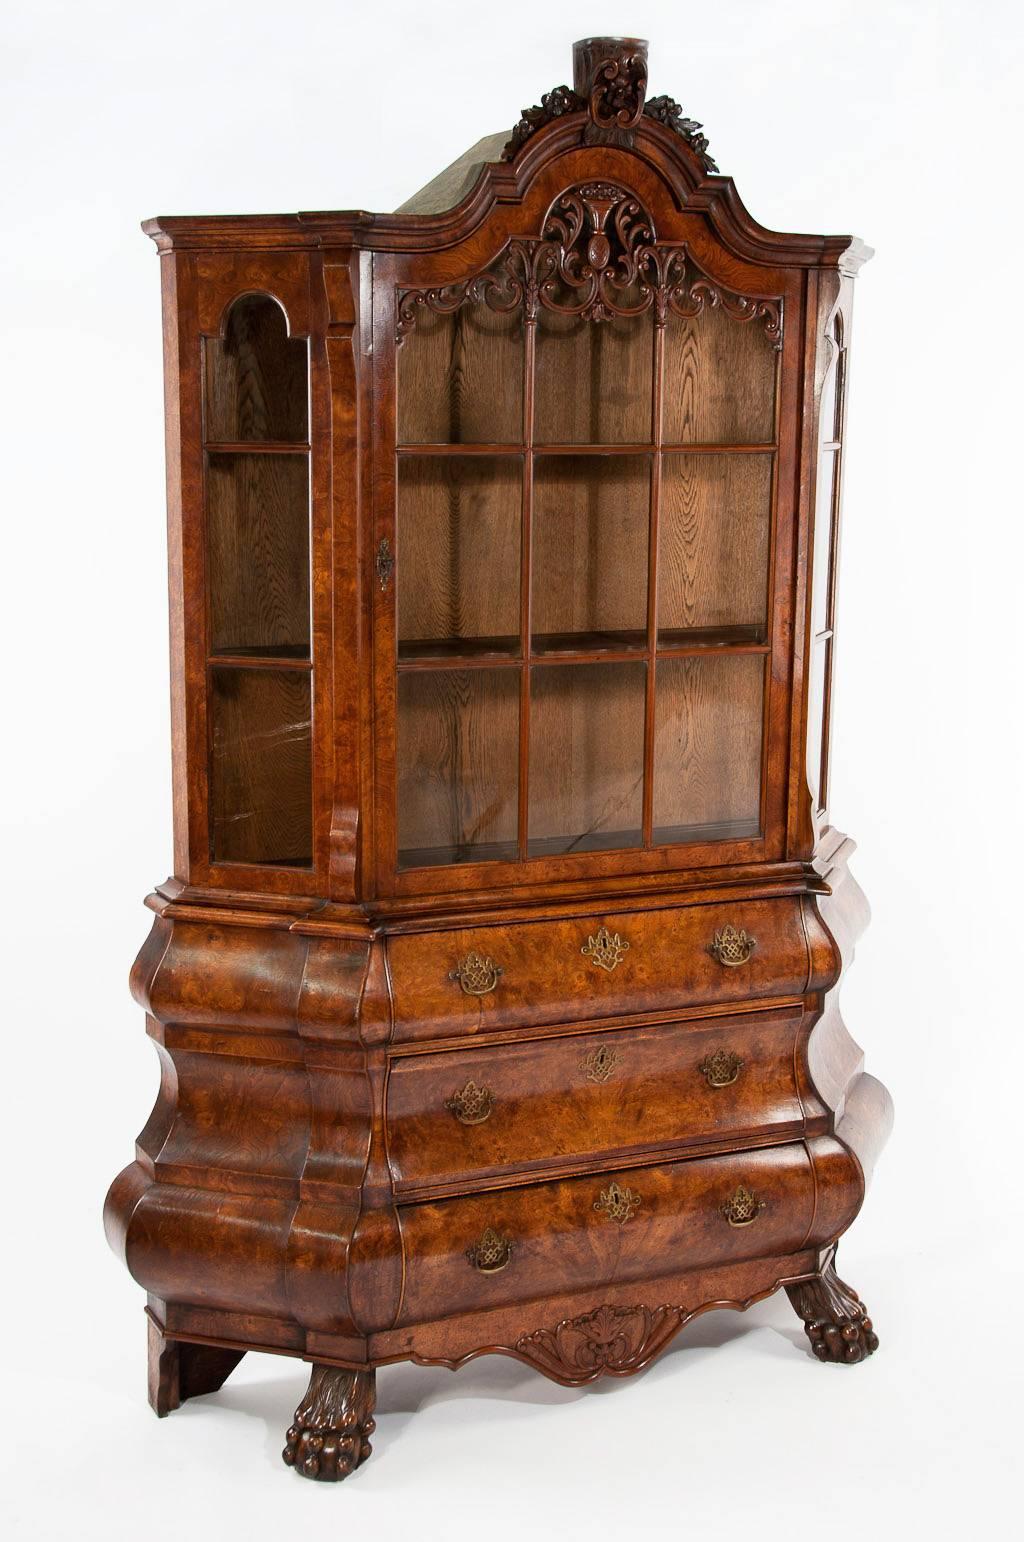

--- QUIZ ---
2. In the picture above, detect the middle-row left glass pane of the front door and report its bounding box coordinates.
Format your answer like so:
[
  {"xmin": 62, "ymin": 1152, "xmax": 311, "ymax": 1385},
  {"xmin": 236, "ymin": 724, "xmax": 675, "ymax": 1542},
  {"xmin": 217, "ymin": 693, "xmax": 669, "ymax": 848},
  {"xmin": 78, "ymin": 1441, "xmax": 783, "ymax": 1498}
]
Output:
[{"xmin": 398, "ymin": 455, "xmax": 523, "ymax": 658}]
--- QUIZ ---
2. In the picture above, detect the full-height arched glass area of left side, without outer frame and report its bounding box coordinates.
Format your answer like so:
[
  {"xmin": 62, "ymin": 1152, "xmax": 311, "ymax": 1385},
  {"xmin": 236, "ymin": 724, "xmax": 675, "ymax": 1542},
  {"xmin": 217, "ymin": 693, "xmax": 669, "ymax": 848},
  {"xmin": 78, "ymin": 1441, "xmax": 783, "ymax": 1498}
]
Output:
[{"xmin": 204, "ymin": 295, "xmax": 313, "ymax": 867}]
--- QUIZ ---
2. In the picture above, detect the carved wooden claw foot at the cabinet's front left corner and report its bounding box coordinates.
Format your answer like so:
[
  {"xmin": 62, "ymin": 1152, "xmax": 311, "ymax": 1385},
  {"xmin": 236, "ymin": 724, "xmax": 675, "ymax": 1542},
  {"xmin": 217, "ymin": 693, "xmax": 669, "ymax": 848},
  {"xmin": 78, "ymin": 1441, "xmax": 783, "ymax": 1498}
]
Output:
[{"xmin": 281, "ymin": 1365, "xmax": 376, "ymax": 1483}]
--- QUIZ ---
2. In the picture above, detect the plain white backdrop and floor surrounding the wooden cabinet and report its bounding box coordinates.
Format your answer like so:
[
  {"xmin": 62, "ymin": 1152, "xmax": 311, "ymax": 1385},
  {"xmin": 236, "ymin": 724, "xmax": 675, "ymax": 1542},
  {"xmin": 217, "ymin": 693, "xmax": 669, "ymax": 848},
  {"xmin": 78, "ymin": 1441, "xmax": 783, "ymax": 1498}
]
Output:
[{"xmin": 0, "ymin": 0, "xmax": 1024, "ymax": 1542}]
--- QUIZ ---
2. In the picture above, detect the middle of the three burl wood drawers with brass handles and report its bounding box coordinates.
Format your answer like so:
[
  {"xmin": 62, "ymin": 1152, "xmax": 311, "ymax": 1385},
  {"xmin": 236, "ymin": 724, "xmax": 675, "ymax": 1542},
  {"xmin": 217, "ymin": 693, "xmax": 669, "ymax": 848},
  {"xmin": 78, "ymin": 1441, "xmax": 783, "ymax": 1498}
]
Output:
[{"xmin": 387, "ymin": 1007, "xmax": 803, "ymax": 1194}]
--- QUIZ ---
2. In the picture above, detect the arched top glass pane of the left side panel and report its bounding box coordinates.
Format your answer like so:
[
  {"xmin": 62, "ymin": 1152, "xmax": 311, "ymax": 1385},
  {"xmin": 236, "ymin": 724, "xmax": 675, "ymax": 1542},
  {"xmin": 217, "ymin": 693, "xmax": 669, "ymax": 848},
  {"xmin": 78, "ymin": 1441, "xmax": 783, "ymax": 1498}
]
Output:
[{"xmin": 204, "ymin": 295, "xmax": 308, "ymax": 444}]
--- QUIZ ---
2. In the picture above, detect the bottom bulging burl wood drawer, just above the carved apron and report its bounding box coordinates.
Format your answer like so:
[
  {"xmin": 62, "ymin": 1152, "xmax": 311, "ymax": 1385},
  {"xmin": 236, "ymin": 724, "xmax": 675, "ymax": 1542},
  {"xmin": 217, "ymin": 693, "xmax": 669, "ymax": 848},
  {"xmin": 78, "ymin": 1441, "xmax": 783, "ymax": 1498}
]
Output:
[{"xmin": 396, "ymin": 1141, "xmax": 814, "ymax": 1326}]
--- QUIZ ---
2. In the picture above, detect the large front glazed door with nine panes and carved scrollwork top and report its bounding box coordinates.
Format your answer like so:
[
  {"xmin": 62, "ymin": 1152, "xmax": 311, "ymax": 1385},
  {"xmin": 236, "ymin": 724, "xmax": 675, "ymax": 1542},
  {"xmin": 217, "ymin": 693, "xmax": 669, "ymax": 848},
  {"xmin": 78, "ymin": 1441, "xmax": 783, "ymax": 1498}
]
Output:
[{"xmin": 373, "ymin": 182, "xmax": 799, "ymax": 891}]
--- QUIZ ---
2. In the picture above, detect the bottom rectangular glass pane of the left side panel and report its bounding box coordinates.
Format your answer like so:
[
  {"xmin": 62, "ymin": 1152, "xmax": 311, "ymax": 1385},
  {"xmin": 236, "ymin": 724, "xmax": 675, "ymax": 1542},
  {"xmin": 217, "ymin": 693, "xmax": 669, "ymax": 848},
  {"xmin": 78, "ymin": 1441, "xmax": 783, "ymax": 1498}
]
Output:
[{"xmin": 210, "ymin": 669, "xmax": 313, "ymax": 867}]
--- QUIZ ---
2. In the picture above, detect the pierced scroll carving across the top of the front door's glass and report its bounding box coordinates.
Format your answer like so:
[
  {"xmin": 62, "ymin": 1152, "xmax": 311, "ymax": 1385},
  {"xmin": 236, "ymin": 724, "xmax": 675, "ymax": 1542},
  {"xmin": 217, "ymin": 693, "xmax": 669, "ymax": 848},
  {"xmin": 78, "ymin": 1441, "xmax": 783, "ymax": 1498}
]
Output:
[{"xmin": 396, "ymin": 182, "xmax": 782, "ymax": 348}]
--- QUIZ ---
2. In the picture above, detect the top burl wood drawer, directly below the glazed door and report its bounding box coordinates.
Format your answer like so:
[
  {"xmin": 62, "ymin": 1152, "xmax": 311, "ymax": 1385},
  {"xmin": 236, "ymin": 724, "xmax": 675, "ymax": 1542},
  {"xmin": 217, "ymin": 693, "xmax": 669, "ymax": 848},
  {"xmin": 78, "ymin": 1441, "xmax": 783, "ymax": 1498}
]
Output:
[{"xmin": 387, "ymin": 897, "xmax": 808, "ymax": 1042}]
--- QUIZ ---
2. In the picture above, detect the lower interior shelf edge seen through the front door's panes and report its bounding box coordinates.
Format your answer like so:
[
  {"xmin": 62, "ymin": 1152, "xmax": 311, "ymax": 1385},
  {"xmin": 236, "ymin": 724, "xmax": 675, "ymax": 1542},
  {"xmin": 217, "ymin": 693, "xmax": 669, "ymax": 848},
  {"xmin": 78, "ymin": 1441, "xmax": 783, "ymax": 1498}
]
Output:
[{"xmin": 398, "ymin": 626, "xmax": 770, "ymax": 669}]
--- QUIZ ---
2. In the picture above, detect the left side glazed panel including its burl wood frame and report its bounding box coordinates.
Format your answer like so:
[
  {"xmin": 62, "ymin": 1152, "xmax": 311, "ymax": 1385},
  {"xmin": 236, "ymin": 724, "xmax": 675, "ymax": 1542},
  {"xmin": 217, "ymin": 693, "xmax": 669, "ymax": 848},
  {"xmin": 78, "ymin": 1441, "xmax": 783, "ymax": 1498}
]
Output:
[{"xmin": 162, "ymin": 253, "xmax": 330, "ymax": 893}]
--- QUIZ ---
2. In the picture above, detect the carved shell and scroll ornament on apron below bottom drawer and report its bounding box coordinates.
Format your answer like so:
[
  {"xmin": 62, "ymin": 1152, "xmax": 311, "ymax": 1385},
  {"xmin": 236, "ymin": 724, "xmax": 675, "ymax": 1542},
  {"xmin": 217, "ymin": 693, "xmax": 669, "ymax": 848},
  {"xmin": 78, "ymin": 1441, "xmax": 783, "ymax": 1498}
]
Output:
[{"xmin": 515, "ymin": 1306, "xmax": 685, "ymax": 1385}]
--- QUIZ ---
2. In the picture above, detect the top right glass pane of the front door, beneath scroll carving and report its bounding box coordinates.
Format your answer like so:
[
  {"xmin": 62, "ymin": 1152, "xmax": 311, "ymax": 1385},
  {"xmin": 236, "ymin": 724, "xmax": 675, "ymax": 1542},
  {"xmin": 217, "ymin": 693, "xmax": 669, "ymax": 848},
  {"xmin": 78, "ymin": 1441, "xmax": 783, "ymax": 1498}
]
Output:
[{"xmin": 665, "ymin": 308, "xmax": 779, "ymax": 444}]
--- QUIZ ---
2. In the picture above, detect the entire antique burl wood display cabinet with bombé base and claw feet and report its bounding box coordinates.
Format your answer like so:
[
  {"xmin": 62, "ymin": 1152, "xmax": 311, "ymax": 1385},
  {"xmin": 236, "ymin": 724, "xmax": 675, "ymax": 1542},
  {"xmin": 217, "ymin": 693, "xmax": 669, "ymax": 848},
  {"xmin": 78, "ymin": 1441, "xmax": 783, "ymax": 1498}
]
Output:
[{"xmin": 106, "ymin": 39, "xmax": 891, "ymax": 1479}]
